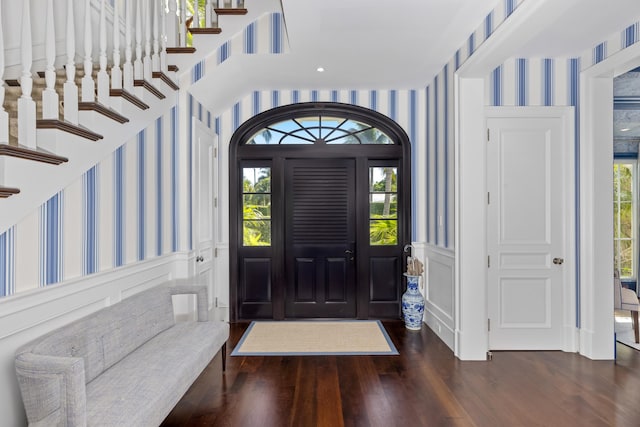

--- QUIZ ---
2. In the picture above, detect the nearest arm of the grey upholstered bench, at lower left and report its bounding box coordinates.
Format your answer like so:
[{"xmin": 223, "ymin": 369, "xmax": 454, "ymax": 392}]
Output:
[{"xmin": 15, "ymin": 353, "xmax": 87, "ymax": 426}]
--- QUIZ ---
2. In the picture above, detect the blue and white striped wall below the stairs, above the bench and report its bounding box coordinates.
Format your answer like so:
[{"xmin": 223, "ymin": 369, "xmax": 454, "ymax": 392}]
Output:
[{"xmin": 0, "ymin": 107, "xmax": 188, "ymax": 296}]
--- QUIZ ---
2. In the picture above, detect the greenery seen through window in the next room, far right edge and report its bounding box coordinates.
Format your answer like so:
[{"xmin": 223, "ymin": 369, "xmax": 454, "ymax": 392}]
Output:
[{"xmin": 613, "ymin": 160, "xmax": 638, "ymax": 279}]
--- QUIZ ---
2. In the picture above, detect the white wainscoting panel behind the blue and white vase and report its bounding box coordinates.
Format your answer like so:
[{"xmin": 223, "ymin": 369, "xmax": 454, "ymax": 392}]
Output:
[{"xmin": 413, "ymin": 243, "xmax": 455, "ymax": 350}]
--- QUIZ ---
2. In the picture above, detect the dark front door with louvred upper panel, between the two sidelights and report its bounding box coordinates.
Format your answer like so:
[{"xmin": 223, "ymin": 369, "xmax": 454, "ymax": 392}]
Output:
[{"xmin": 284, "ymin": 159, "xmax": 357, "ymax": 318}]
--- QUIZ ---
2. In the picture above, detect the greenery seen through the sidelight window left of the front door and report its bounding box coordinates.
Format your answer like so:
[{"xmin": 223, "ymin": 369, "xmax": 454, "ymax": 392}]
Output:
[{"xmin": 242, "ymin": 167, "xmax": 271, "ymax": 246}]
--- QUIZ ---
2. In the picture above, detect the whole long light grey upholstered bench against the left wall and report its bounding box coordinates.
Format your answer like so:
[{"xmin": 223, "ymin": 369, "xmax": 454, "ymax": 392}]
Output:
[{"xmin": 15, "ymin": 285, "xmax": 229, "ymax": 427}]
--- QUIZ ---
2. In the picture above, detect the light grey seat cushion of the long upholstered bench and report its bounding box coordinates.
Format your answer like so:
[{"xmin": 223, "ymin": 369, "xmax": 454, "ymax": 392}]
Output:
[{"xmin": 87, "ymin": 321, "xmax": 229, "ymax": 427}]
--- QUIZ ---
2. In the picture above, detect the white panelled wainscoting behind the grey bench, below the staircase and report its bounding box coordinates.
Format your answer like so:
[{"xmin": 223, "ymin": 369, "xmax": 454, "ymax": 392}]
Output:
[{"xmin": 0, "ymin": 252, "xmax": 193, "ymax": 426}]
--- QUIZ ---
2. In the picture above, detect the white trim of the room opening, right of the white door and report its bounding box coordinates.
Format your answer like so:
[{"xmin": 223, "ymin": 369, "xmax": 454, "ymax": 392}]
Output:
[{"xmin": 580, "ymin": 43, "xmax": 640, "ymax": 359}]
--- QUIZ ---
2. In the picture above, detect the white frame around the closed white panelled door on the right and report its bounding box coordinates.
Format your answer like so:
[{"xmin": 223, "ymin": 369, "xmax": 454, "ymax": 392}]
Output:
[{"xmin": 484, "ymin": 106, "xmax": 577, "ymax": 351}]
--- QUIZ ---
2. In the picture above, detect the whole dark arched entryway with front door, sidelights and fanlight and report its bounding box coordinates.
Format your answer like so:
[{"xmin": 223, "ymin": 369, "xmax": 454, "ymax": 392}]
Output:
[{"xmin": 229, "ymin": 103, "xmax": 411, "ymax": 320}]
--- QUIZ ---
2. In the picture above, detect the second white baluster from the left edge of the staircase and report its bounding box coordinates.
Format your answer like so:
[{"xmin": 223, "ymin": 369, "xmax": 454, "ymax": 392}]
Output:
[{"xmin": 18, "ymin": 1, "xmax": 36, "ymax": 149}]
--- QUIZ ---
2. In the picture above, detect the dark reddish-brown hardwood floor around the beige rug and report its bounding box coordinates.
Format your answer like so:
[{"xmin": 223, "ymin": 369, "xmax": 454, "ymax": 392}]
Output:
[{"xmin": 162, "ymin": 321, "xmax": 640, "ymax": 427}]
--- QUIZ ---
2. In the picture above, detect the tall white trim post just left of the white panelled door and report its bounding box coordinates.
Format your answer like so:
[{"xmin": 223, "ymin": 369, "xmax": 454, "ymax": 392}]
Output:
[{"xmin": 454, "ymin": 75, "xmax": 489, "ymax": 360}]
